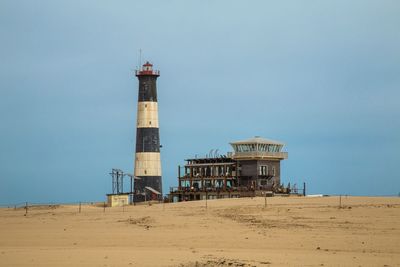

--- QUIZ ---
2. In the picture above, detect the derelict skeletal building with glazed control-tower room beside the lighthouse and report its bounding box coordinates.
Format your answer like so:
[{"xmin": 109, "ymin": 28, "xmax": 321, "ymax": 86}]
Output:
[{"xmin": 169, "ymin": 136, "xmax": 290, "ymax": 201}]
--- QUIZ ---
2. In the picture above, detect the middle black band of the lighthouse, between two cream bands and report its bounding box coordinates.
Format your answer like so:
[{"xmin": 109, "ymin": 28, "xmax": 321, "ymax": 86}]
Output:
[{"xmin": 136, "ymin": 128, "xmax": 160, "ymax": 153}]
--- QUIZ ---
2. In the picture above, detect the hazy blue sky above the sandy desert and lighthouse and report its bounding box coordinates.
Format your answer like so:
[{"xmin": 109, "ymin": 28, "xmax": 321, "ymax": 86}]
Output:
[{"xmin": 0, "ymin": 0, "xmax": 400, "ymax": 205}]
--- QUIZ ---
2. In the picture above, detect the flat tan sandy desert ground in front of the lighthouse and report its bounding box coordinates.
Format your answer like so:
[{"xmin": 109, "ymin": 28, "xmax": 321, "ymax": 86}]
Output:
[{"xmin": 0, "ymin": 197, "xmax": 400, "ymax": 267}]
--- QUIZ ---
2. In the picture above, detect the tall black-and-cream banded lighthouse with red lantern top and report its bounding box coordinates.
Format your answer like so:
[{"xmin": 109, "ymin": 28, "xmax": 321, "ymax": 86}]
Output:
[{"xmin": 134, "ymin": 62, "xmax": 162, "ymax": 201}]
